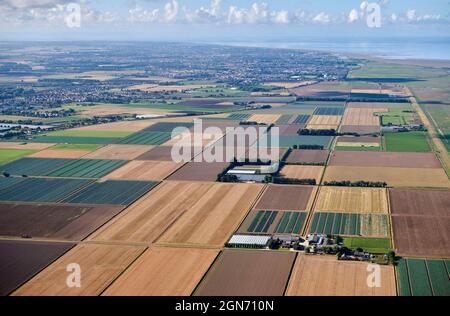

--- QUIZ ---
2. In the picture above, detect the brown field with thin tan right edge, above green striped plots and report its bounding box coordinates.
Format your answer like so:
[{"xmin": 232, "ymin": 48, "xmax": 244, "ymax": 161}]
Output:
[{"xmin": 255, "ymin": 185, "xmax": 317, "ymax": 211}]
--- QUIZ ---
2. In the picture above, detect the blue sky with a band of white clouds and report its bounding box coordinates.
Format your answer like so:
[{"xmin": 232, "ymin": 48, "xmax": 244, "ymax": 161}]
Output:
[{"xmin": 0, "ymin": 0, "xmax": 450, "ymax": 42}]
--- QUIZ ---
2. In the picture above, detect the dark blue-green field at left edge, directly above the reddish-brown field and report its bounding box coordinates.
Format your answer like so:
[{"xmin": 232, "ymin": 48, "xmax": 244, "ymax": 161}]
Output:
[{"xmin": 0, "ymin": 178, "xmax": 90, "ymax": 202}]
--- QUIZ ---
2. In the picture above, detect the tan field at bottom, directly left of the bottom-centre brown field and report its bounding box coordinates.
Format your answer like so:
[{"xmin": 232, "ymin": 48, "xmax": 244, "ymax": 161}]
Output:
[{"xmin": 103, "ymin": 247, "xmax": 219, "ymax": 296}]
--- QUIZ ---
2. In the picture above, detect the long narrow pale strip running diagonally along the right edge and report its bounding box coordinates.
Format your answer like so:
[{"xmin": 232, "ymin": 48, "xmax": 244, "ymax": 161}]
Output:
[{"xmin": 405, "ymin": 87, "xmax": 450, "ymax": 176}]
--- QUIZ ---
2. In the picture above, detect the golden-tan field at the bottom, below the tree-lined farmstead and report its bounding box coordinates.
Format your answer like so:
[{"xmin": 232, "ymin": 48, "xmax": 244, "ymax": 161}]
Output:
[{"xmin": 286, "ymin": 255, "xmax": 397, "ymax": 296}]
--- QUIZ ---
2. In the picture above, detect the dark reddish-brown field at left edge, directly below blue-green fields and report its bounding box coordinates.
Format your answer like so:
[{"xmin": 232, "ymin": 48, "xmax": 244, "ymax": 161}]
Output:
[{"xmin": 0, "ymin": 203, "xmax": 122, "ymax": 240}]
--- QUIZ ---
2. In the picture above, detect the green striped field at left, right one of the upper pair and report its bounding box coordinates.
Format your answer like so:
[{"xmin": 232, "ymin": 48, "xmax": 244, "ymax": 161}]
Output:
[{"xmin": 48, "ymin": 159, "xmax": 128, "ymax": 178}]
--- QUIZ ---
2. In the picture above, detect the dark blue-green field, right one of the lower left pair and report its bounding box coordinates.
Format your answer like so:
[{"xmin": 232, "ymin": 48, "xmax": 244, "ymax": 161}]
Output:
[{"xmin": 64, "ymin": 181, "xmax": 157, "ymax": 205}]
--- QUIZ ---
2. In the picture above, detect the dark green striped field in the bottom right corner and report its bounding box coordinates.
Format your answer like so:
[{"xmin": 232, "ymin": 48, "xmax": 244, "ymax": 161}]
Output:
[{"xmin": 396, "ymin": 258, "xmax": 450, "ymax": 296}]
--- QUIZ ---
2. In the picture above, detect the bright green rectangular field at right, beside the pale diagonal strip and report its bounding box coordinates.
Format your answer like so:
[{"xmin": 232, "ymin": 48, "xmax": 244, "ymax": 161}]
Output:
[{"xmin": 384, "ymin": 132, "xmax": 430, "ymax": 152}]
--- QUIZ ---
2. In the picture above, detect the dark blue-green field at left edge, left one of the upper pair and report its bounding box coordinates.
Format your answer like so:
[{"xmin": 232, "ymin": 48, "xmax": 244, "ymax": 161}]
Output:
[{"xmin": 0, "ymin": 158, "xmax": 75, "ymax": 176}]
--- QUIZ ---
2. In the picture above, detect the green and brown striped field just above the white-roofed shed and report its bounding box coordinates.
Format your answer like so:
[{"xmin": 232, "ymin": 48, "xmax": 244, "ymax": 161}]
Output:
[{"xmin": 238, "ymin": 211, "xmax": 307, "ymax": 235}]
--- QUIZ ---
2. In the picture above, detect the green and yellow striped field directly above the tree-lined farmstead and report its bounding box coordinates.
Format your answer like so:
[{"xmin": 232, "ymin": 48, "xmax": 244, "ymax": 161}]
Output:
[{"xmin": 309, "ymin": 212, "xmax": 389, "ymax": 237}]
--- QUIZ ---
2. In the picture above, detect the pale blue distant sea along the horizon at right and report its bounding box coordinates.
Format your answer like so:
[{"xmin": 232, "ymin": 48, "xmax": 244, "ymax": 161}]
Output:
[{"xmin": 215, "ymin": 37, "xmax": 450, "ymax": 60}]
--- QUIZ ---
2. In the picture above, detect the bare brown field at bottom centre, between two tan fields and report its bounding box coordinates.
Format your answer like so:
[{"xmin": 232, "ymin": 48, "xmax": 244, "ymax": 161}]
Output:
[{"xmin": 194, "ymin": 250, "xmax": 295, "ymax": 296}]
